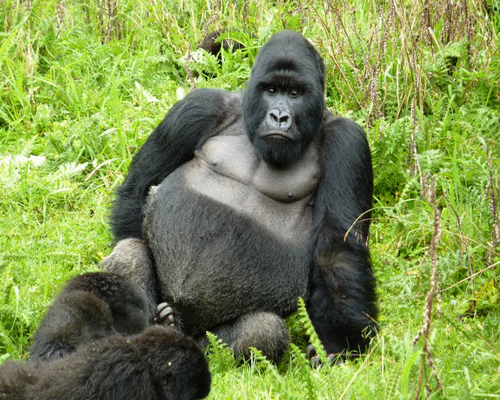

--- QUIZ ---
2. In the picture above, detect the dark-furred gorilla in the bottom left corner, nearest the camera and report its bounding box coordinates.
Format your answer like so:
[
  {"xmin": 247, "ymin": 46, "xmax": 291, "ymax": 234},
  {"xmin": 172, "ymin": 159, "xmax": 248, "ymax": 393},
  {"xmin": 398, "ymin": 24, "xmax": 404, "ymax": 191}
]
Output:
[{"xmin": 0, "ymin": 326, "xmax": 211, "ymax": 400}]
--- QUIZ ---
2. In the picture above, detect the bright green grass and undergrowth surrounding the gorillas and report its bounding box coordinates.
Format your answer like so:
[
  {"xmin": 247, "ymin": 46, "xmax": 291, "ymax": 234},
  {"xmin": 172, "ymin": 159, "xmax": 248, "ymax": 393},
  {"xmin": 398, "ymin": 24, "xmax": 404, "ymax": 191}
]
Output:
[{"xmin": 0, "ymin": 0, "xmax": 500, "ymax": 399}]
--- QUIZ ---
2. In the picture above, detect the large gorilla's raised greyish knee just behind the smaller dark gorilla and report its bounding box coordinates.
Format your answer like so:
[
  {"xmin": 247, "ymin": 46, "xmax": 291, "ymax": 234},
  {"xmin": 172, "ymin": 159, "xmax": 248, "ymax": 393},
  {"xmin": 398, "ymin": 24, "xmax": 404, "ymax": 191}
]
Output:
[{"xmin": 101, "ymin": 238, "xmax": 158, "ymax": 304}]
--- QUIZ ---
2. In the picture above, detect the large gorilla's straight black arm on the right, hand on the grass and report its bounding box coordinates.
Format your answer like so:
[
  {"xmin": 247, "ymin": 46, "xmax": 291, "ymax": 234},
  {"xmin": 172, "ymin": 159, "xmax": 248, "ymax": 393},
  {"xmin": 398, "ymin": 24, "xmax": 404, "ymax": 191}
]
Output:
[{"xmin": 308, "ymin": 118, "xmax": 377, "ymax": 353}]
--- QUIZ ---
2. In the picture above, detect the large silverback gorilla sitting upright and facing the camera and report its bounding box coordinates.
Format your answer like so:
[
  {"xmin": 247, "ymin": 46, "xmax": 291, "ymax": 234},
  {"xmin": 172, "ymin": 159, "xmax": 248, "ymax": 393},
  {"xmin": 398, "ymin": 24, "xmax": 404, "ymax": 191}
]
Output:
[{"xmin": 104, "ymin": 31, "xmax": 377, "ymax": 360}]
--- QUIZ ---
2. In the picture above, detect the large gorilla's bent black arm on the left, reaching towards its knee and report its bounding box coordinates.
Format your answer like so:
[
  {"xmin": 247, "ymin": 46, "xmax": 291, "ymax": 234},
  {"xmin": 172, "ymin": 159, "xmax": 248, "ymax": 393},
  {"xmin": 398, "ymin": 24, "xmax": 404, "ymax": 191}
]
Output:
[{"xmin": 111, "ymin": 89, "xmax": 229, "ymax": 242}]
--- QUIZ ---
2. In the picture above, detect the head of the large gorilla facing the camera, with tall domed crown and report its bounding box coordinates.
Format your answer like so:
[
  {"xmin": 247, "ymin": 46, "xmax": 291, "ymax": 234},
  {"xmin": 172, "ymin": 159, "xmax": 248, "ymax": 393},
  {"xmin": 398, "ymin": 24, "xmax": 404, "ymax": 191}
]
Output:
[{"xmin": 243, "ymin": 31, "xmax": 325, "ymax": 165}]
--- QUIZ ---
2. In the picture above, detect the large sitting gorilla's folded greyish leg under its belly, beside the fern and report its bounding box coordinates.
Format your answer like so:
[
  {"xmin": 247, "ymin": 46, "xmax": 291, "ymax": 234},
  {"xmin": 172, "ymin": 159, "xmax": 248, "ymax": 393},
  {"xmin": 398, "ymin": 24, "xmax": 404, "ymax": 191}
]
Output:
[{"xmin": 198, "ymin": 311, "xmax": 289, "ymax": 362}]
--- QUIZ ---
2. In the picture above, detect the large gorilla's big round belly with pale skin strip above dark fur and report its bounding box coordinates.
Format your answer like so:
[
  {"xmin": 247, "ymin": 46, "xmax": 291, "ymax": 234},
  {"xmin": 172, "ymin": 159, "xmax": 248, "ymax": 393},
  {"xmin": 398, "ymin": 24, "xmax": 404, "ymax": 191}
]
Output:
[{"xmin": 143, "ymin": 138, "xmax": 314, "ymax": 333}]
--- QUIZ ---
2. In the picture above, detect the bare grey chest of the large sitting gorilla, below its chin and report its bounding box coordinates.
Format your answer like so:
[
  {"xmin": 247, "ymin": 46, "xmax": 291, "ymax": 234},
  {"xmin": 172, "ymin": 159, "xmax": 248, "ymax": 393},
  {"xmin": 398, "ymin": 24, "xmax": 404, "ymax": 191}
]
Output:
[{"xmin": 183, "ymin": 131, "xmax": 319, "ymax": 242}]
